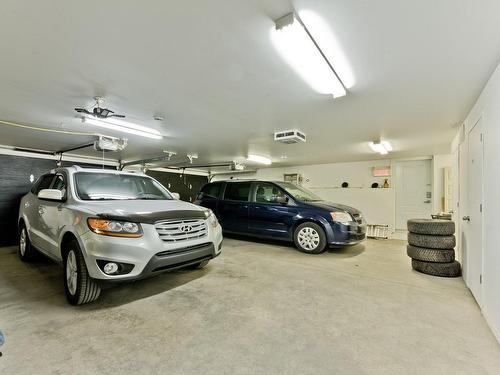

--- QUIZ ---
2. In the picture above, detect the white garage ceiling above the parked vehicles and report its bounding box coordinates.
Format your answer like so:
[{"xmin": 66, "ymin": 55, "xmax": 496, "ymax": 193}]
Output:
[{"xmin": 0, "ymin": 0, "xmax": 500, "ymax": 165}]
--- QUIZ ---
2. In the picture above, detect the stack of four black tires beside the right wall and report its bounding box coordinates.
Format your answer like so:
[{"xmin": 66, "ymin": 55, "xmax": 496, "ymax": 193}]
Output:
[{"xmin": 407, "ymin": 219, "xmax": 461, "ymax": 277}]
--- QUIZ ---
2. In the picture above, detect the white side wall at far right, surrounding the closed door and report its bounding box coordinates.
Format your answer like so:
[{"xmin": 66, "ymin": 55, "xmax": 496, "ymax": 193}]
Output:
[{"xmin": 453, "ymin": 60, "xmax": 500, "ymax": 341}]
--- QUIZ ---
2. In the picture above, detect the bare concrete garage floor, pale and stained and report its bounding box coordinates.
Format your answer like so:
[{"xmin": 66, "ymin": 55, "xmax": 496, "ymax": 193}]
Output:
[{"xmin": 0, "ymin": 238, "xmax": 500, "ymax": 375}]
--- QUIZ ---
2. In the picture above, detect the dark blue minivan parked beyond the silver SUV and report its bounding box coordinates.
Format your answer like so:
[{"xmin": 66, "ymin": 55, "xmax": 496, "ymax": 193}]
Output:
[{"xmin": 195, "ymin": 180, "xmax": 366, "ymax": 254}]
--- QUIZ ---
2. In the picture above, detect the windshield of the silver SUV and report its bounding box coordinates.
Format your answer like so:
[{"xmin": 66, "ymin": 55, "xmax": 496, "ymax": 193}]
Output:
[{"xmin": 75, "ymin": 172, "xmax": 173, "ymax": 201}]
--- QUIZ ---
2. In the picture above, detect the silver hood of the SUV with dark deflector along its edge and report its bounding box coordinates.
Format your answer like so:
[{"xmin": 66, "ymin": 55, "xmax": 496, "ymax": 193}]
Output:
[{"xmin": 80, "ymin": 200, "xmax": 206, "ymax": 224}]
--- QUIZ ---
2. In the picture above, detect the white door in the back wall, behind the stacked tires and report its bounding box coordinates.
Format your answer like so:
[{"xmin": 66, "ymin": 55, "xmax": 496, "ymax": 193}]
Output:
[{"xmin": 395, "ymin": 160, "xmax": 432, "ymax": 229}]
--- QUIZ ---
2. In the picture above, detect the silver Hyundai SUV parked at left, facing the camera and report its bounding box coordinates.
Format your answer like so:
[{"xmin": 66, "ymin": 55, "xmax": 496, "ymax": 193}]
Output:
[{"xmin": 19, "ymin": 166, "xmax": 222, "ymax": 305}]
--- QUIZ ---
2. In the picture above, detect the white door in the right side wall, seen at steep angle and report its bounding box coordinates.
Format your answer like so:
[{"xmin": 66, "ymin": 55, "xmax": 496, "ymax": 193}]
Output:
[{"xmin": 463, "ymin": 119, "xmax": 483, "ymax": 306}]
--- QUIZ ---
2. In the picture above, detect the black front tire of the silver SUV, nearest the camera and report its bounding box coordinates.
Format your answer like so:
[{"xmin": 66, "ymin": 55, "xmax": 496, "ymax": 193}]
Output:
[{"xmin": 63, "ymin": 240, "xmax": 101, "ymax": 305}]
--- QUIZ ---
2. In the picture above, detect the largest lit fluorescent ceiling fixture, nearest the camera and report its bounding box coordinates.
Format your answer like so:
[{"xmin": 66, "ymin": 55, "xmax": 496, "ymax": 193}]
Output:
[{"xmin": 271, "ymin": 13, "xmax": 346, "ymax": 98}]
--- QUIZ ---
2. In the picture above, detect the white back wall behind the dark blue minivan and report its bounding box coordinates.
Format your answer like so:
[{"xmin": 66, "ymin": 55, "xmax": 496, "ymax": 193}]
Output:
[{"xmin": 212, "ymin": 155, "xmax": 444, "ymax": 235}]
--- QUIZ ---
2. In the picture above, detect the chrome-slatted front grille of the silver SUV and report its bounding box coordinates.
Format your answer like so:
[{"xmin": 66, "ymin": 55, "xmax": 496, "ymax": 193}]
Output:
[{"xmin": 155, "ymin": 219, "xmax": 207, "ymax": 242}]
